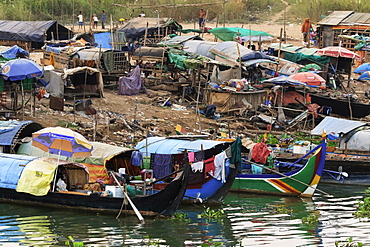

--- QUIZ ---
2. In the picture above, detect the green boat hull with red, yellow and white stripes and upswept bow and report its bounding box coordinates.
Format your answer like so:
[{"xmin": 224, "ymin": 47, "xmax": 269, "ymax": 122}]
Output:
[{"xmin": 231, "ymin": 141, "xmax": 326, "ymax": 197}]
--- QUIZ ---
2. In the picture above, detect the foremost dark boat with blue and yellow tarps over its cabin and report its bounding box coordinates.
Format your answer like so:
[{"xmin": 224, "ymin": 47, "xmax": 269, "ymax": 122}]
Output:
[{"xmin": 0, "ymin": 154, "xmax": 189, "ymax": 216}]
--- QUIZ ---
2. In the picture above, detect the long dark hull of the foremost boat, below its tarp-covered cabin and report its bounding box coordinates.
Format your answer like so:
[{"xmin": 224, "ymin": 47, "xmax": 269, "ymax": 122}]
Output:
[{"xmin": 0, "ymin": 169, "xmax": 189, "ymax": 216}]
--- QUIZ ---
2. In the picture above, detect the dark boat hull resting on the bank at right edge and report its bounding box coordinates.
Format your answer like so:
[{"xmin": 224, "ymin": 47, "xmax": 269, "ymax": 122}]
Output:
[{"xmin": 310, "ymin": 93, "xmax": 370, "ymax": 118}]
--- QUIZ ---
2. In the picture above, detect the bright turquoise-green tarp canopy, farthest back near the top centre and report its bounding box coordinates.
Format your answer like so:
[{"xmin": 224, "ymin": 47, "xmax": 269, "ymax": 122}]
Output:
[{"xmin": 208, "ymin": 27, "xmax": 273, "ymax": 41}]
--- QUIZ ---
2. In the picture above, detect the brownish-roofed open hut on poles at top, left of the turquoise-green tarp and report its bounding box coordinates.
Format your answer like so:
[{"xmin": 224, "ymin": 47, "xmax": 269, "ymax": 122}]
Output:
[{"xmin": 118, "ymin": 17, "xmax": 182, "ymax": 45}]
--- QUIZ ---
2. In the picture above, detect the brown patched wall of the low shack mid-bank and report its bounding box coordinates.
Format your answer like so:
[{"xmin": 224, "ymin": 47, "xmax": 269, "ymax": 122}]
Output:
[{"xmin": 204, "ymin": 89, "xmax": 266, "ymax": 113}]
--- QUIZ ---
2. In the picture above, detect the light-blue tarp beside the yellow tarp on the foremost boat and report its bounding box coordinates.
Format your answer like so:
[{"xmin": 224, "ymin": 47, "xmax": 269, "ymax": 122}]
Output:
[{"xmin": 0, "ymin": 154, "xmax": 38, "ymax": 189}]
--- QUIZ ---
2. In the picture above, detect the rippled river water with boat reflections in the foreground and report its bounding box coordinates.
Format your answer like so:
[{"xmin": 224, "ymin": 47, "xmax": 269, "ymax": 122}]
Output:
[{"xmin": 0, "ymin": 185, "xmax": 370, "ymax": 247}]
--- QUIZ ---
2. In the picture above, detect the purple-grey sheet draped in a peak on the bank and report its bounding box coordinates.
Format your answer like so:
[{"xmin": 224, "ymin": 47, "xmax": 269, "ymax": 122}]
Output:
[{"xmin": 118, "ymin": 66, "xmax": 142, "ymax": 95}]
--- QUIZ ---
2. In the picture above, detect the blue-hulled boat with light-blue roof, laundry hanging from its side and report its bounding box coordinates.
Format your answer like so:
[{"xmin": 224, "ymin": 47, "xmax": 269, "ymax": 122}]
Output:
[{"xmin": 136, "ymin": 136, "xmax": 241, "ymax": 203}]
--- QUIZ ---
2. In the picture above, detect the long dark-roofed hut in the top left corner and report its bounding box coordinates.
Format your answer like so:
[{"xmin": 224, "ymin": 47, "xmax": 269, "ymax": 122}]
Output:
[{"xmin": 0, "ymin": 20, "xmax": 72, "ymax": 51}]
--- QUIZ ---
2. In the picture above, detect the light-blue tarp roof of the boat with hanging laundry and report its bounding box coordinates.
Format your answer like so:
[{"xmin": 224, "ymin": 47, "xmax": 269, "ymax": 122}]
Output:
[{"xmin": 135, "ymin": 137, "xmax": 225, "ymax": 156}]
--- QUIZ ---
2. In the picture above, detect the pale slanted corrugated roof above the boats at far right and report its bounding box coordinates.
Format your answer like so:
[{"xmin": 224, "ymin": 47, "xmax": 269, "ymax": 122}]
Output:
[{"xmin": 311, "ymin": 117, "xmax": 366, "ymax": 135}]
